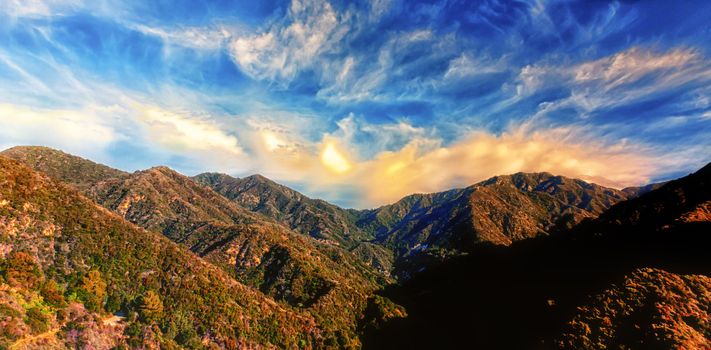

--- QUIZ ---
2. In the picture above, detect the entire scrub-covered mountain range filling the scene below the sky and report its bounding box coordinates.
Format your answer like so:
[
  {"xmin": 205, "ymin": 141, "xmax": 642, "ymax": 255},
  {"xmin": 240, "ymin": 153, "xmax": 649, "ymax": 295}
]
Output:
[{"xmin": 0, "ymin": 147, "xmax": 711, "ymax": 348}]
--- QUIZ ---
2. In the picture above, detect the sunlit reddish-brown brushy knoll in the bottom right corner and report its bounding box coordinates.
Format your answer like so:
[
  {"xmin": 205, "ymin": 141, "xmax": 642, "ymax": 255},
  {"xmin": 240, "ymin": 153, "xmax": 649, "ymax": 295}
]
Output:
[{"xmin": 556, "ymin": 268, "xmax": 711, "ymax": 349}]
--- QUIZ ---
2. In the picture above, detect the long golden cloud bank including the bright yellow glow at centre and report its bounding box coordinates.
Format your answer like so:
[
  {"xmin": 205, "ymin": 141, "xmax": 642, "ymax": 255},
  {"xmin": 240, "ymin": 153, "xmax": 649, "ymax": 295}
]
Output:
[{"xmin": 229, "ymin": 115, "xmax": 668, "ymax": 208}]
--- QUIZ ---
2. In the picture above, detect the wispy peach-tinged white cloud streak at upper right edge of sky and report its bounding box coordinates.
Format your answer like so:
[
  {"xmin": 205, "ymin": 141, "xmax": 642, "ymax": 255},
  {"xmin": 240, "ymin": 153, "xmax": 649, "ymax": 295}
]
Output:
[{"xmin": 512, "ymin": 47, "xmax": 711, "ymax": 115}]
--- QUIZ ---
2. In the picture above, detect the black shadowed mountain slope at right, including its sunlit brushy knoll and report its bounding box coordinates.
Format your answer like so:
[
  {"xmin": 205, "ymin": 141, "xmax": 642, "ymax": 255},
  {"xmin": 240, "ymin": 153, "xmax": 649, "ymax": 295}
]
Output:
[{"xmin": 363, "ymin": 166, "xmax": 711, "ymax": 349}]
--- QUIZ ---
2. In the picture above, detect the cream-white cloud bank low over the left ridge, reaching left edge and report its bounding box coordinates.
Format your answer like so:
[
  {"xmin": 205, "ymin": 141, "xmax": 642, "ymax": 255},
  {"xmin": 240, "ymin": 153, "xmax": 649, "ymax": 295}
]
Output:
[{"xmin": 0, "ymin": 96, "xmax": 254, "ymax": 172}]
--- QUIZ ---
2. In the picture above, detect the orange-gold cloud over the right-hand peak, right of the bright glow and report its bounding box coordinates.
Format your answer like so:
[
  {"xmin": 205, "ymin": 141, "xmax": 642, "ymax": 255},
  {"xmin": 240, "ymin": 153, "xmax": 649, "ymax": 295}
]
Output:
[{"xmin": 353, "ymin": 123, "xmax": 661, "ymax": 206}]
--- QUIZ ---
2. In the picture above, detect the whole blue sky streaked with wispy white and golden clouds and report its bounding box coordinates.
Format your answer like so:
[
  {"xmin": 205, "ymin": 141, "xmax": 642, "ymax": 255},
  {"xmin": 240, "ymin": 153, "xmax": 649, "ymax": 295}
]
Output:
[{"xmin": 0, "ymin": 0, "xmax": 711, "ymax": 208}]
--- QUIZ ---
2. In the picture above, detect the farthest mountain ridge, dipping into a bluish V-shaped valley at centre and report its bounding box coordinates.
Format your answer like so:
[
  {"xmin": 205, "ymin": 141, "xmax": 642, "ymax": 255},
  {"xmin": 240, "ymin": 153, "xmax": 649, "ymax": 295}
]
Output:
[{"xmin": 194, "ymin": 173, "xmax": 642, "ymax": 277}]
